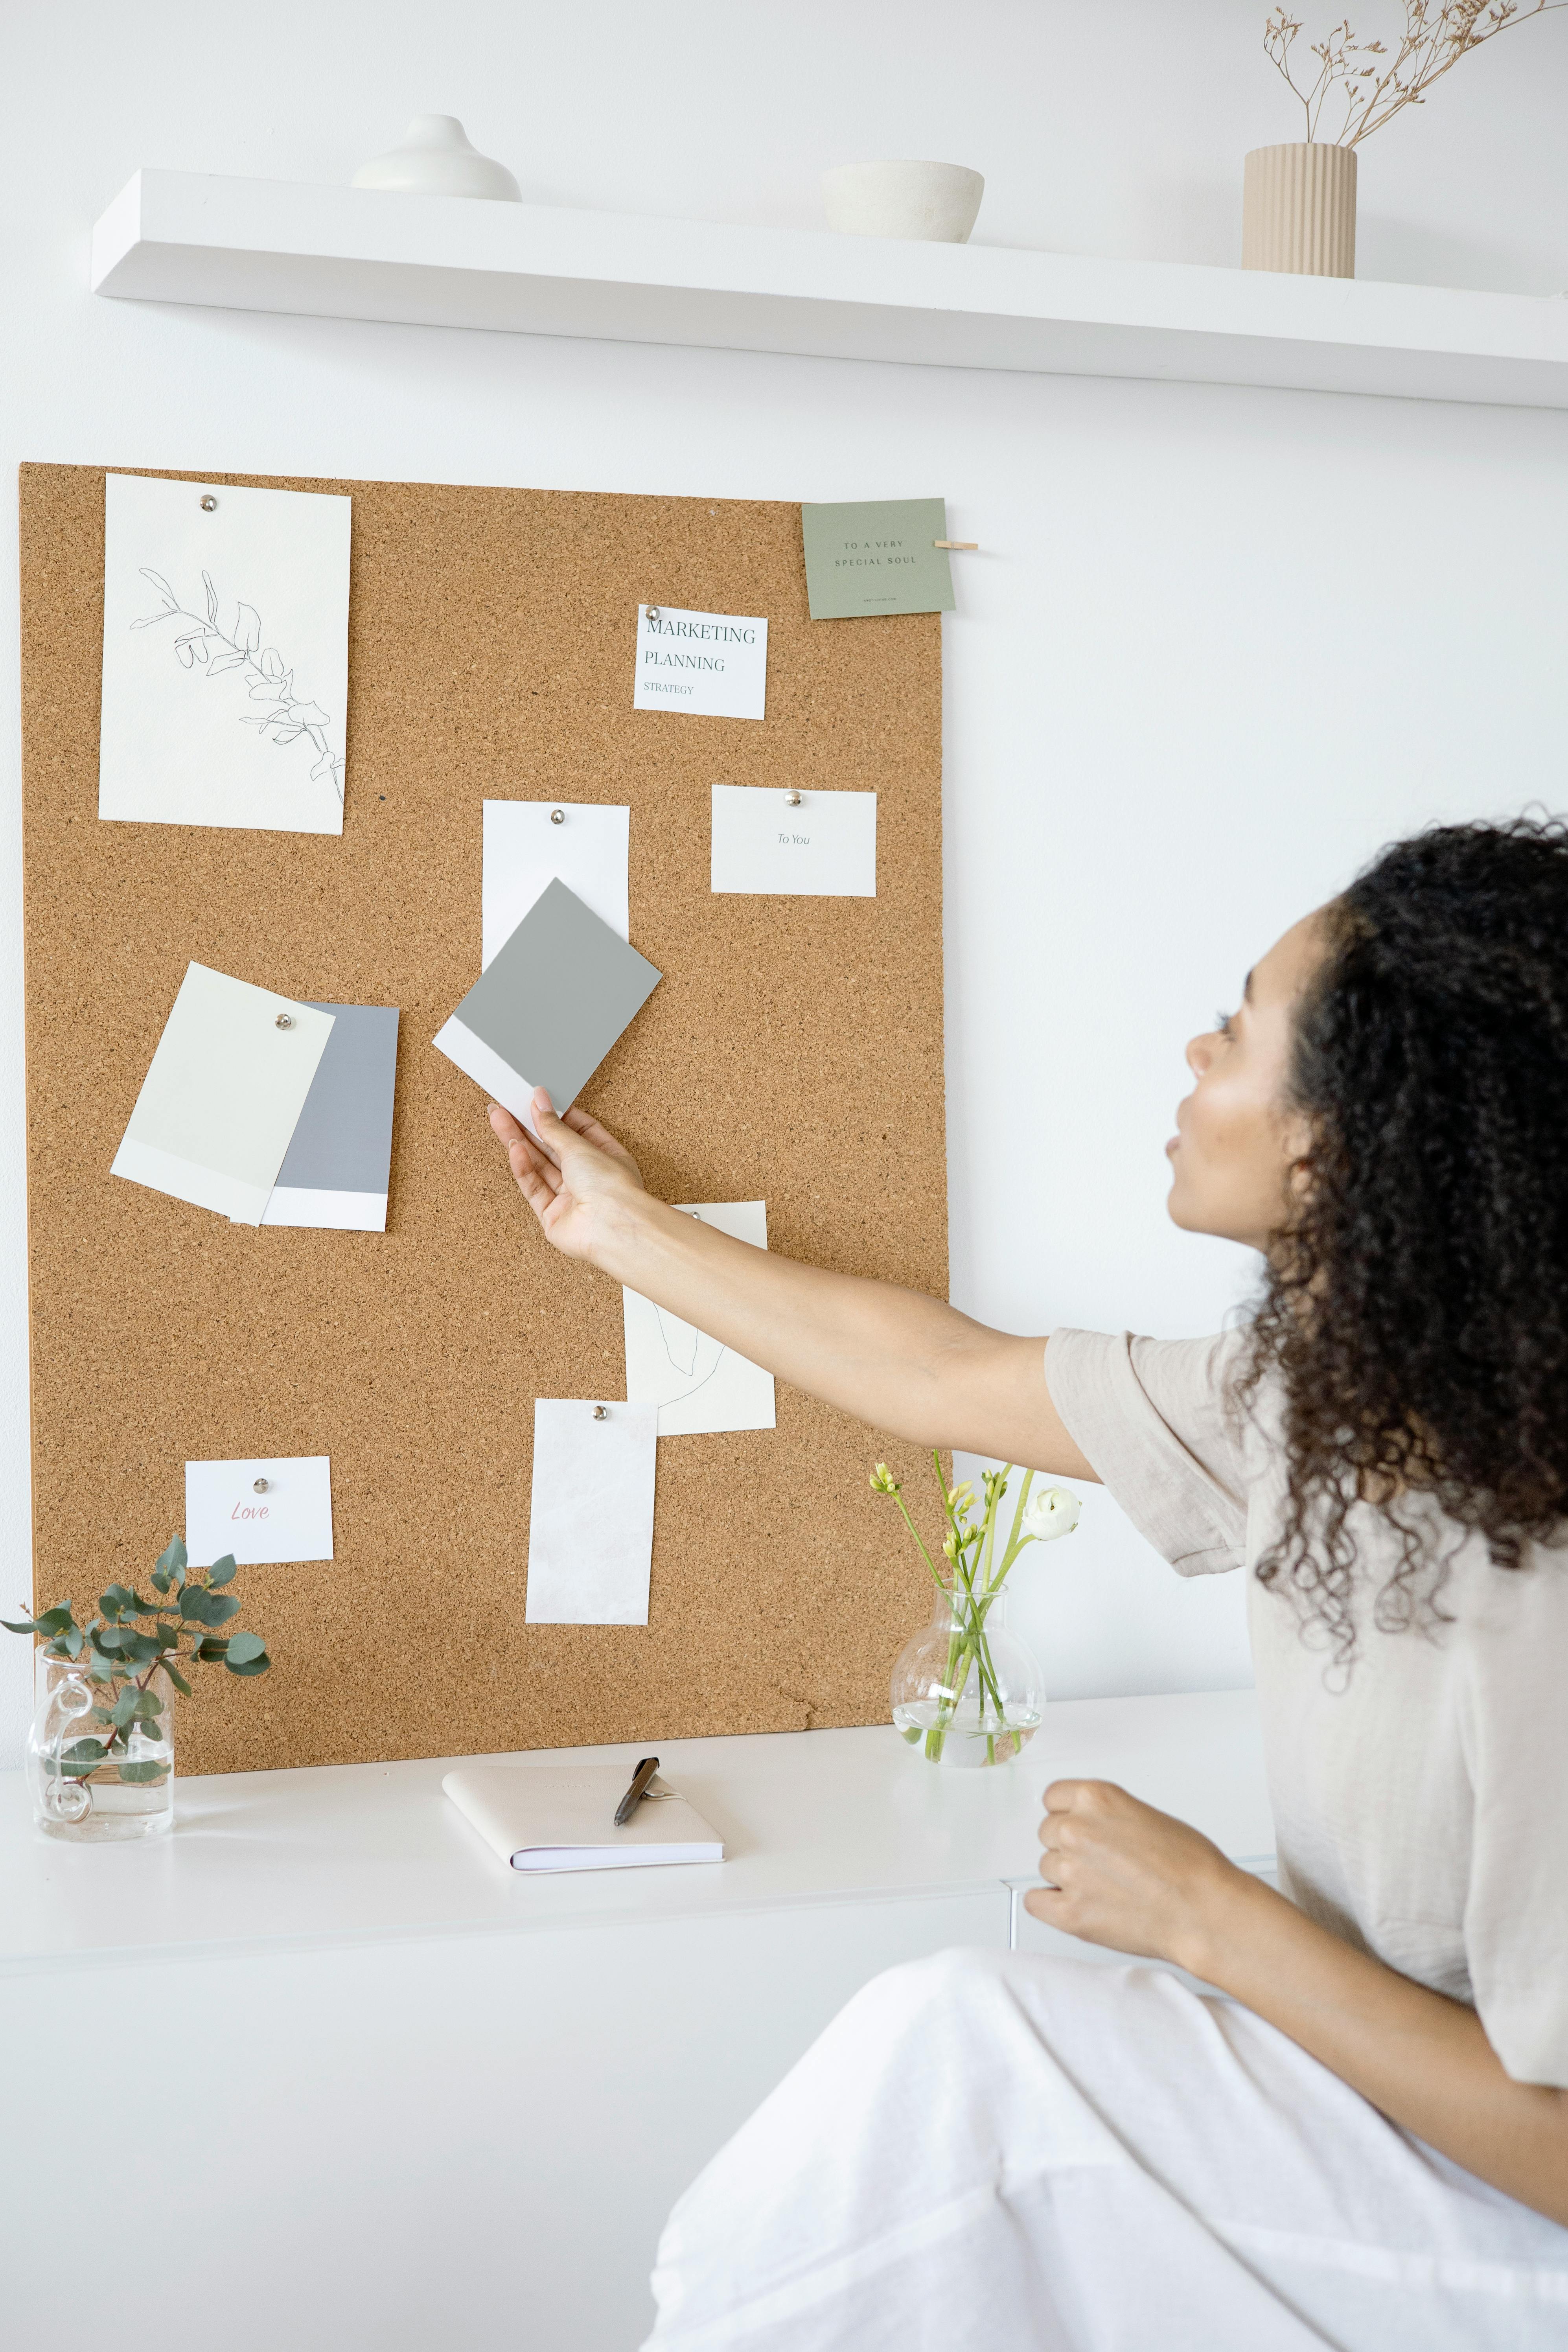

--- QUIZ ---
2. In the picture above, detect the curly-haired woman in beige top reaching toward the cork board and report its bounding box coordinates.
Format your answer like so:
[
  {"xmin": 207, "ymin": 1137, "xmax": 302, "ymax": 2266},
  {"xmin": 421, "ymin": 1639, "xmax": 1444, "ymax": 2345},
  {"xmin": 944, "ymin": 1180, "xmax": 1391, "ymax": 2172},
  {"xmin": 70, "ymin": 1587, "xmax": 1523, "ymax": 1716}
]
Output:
[{"xmin": 491, "ymin": 821, "xmax": 1568, "ymax": 2352}]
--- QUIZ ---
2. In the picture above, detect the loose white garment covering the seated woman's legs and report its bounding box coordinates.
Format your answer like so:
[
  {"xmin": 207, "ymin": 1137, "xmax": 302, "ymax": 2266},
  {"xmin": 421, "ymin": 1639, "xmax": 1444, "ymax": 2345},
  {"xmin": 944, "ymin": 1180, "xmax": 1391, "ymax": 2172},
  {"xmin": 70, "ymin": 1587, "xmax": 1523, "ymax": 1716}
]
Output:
[{"xmin": 649, "ymin": 1952, "xmax": 1568, "ymax": 2352}]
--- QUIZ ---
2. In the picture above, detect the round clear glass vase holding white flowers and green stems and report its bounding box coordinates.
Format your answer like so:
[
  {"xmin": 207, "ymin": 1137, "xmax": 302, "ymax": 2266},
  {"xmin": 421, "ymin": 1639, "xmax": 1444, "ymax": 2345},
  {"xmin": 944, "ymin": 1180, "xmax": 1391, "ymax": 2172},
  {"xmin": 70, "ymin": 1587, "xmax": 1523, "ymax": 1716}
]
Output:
[{"xmin": 891, "ymin": 1585, "xmax": 1046, "ymax": 1766}]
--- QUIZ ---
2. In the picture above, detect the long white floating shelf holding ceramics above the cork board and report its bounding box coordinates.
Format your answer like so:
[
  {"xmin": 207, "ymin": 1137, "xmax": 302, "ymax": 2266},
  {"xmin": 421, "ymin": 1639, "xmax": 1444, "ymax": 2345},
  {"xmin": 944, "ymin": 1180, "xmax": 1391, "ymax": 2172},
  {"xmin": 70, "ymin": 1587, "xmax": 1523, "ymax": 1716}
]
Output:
[{"xmin": 92, "ymin": 172, "xmax": 1568, "ymax": 409}]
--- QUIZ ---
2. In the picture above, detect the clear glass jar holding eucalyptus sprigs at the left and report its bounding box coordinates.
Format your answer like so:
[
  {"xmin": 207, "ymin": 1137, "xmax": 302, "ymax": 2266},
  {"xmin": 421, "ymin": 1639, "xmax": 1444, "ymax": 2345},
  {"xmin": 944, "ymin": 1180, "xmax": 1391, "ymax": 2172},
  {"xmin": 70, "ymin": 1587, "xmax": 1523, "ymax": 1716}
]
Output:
[{"xmin": 28, "ymin": 1656, "xmax": 174, "ymax": 1844}]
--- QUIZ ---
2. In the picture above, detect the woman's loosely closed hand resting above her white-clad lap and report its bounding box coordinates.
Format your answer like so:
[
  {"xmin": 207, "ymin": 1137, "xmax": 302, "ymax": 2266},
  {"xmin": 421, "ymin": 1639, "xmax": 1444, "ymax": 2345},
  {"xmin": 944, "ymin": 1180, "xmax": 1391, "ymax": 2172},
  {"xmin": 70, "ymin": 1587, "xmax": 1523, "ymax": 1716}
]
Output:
[{"xmin": 1023, "ymin": 1780, "xmax": 1251, "ymax": 1976}]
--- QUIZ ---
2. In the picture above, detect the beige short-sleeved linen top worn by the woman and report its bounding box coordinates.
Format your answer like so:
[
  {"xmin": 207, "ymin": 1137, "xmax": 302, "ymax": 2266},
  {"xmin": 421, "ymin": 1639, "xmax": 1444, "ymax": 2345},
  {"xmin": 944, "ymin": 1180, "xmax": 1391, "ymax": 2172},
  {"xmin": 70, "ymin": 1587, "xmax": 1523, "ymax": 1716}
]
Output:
[{"xmin": 1046, "ymin": 1331, "xmax": 1568, "ymax": 2084}]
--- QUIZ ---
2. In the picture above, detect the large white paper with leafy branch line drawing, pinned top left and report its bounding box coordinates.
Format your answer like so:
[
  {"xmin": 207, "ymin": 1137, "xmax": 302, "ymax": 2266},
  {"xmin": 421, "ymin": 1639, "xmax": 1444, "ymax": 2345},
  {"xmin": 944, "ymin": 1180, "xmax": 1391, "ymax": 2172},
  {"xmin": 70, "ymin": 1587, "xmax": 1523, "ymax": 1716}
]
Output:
[{"xmin": 99, "ymin": 473, "xmax": 353, "ymax": 833}]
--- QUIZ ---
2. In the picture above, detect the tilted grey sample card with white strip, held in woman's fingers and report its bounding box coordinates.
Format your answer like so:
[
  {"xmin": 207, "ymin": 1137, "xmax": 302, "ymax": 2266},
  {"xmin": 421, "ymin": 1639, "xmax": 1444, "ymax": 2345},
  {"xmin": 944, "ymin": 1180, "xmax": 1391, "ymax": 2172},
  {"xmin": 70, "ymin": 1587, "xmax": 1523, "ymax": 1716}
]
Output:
[{"xmin": 435, "ymin": 882, "xmax": 663, "ymax": 1131}]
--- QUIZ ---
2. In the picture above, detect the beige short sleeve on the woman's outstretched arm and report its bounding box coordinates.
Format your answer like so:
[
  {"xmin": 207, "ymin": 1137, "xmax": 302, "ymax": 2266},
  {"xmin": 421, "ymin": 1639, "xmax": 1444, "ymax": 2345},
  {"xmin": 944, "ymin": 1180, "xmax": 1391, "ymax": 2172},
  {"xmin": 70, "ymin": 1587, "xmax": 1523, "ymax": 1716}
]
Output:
[{"xmin": 1046, "ymin": 1331, "xmax": 1246, "ymax": 1576}]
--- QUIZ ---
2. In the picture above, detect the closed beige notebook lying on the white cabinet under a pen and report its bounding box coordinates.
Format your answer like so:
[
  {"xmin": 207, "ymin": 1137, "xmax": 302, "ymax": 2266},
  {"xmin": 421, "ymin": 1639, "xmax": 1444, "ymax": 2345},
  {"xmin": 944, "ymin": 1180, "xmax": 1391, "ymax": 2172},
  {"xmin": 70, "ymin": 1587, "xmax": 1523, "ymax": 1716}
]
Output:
[{"xmin": 442, "ymin": 1764, "xmax": 724, "ymax": 1870}]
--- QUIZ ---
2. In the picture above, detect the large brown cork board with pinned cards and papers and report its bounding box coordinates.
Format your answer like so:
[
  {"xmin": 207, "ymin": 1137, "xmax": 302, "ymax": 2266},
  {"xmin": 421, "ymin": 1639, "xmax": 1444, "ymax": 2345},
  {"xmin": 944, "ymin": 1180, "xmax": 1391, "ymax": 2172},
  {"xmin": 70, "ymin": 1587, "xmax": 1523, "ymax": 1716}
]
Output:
[{"xmin": 21, "ymin": 466, "xmax": 948, "ymax": 1771}]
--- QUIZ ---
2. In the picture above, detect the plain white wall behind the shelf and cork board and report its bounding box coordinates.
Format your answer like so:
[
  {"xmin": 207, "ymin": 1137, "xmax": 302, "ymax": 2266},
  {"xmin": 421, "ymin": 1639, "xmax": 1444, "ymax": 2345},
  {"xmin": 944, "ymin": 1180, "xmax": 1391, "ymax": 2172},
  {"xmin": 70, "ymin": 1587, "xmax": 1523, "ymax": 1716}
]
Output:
[{"xmin": 0, "ymin": 0, "xmax": 1568, "ymax": 1769}]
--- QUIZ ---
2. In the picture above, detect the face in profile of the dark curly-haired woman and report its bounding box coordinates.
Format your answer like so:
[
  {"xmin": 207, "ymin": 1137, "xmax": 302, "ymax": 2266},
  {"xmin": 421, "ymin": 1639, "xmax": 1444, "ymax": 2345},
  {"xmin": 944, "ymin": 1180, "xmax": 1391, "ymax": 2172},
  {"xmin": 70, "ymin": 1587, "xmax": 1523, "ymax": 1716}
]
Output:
[{"xmin": 1166, "ymin": 913, "xmax": 1323, "ymax": 1249}]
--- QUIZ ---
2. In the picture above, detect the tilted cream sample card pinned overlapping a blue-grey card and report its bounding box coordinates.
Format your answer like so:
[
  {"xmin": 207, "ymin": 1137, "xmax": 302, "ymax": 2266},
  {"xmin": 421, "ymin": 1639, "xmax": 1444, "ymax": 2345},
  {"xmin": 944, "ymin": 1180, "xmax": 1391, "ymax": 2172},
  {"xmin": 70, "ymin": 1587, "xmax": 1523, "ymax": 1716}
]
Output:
[{"xmin": 113, "ymin": 964, "xmax": 331, "ymax": 1226}]
